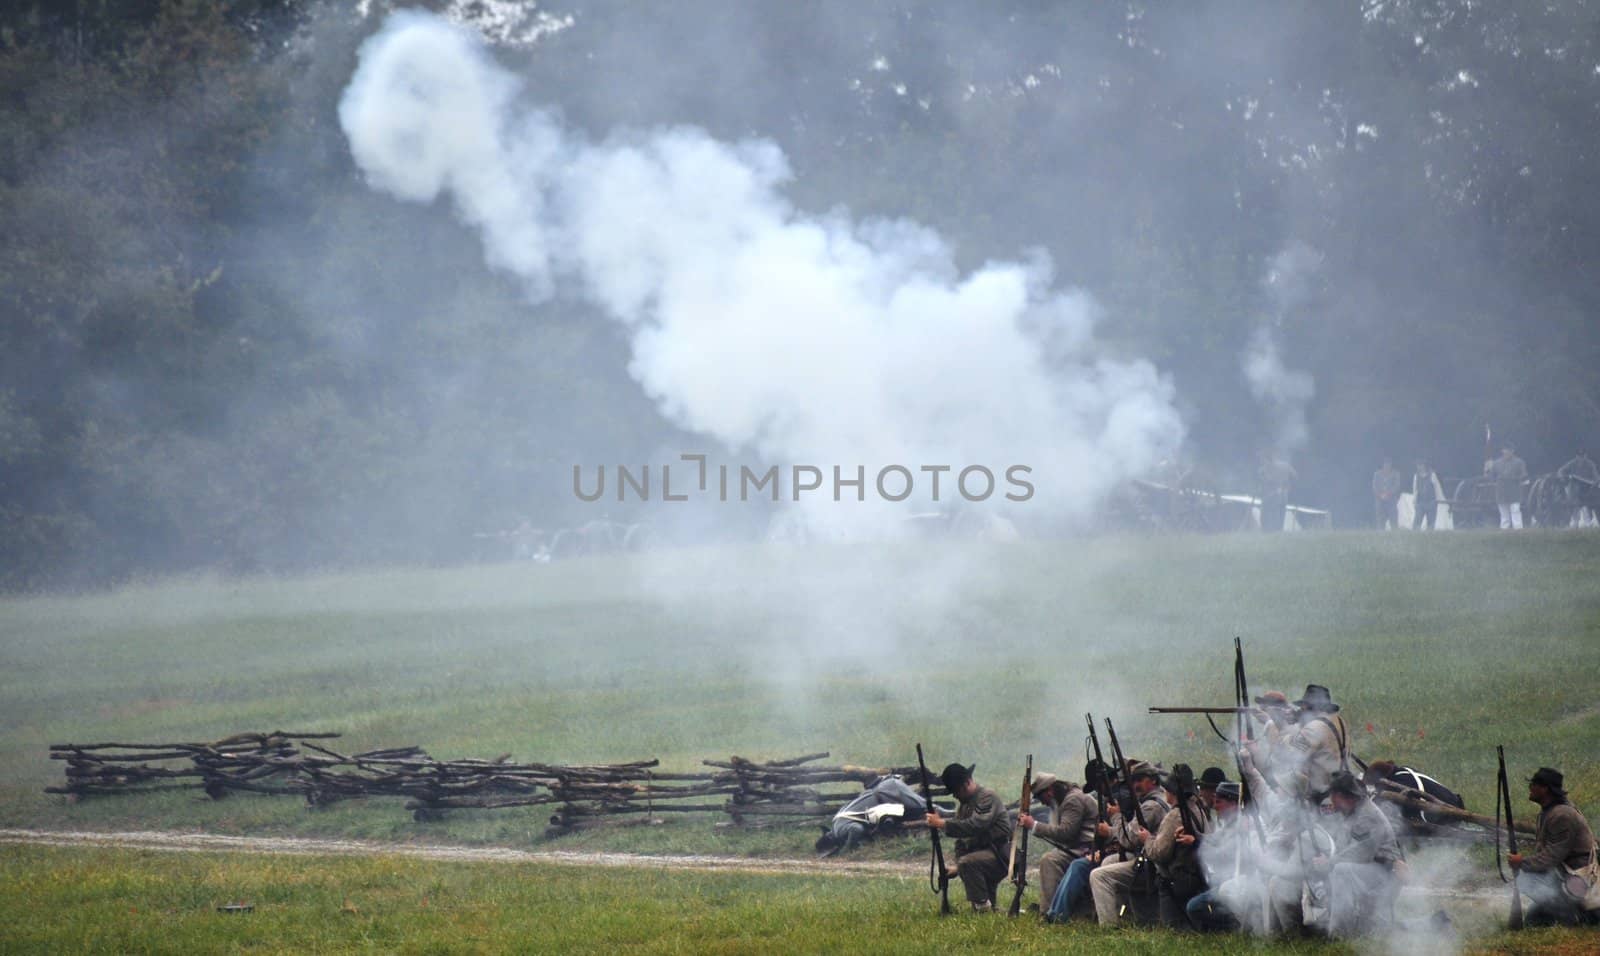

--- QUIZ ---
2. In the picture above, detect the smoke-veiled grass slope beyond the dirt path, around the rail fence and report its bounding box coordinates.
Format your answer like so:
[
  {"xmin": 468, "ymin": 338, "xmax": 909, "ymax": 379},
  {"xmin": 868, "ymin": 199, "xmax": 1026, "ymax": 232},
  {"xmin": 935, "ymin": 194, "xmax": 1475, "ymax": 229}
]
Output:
[{"xmin": 0, "ymin": 532, "xmax": 1600, "ymax": 948}]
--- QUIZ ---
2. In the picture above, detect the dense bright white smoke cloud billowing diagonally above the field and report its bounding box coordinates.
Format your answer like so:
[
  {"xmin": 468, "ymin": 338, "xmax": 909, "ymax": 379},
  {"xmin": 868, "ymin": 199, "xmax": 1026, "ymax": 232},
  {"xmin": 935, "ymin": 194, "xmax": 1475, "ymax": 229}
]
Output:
[{"xmin": 339, "ymin": 13, "xmax": 1182, "ymax": 530}]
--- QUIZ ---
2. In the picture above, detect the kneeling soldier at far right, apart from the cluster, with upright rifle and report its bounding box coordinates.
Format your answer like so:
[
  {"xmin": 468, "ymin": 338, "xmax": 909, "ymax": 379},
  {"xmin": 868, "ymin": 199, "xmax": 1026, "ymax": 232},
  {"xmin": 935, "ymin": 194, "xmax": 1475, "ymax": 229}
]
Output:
[{"xmin": 1509, "ymin": 767, "xmax": 1597, "ymax": 922}]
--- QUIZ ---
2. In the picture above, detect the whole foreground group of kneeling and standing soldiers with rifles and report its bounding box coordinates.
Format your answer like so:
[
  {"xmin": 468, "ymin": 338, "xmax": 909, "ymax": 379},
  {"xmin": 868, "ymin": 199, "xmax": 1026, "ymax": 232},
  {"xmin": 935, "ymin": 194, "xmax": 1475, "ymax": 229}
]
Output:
[{"xmin": 926, "ymin": 684, "xmax": 1595, "ymax": 938}]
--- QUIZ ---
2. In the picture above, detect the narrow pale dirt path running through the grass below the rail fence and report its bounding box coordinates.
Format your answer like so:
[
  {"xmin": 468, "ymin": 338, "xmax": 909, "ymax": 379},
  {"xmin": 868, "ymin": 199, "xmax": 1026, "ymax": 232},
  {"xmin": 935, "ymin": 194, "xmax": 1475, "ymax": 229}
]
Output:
[{"xmin": 0, "ymin": 830, "xmax": 923, "ymax": 878}]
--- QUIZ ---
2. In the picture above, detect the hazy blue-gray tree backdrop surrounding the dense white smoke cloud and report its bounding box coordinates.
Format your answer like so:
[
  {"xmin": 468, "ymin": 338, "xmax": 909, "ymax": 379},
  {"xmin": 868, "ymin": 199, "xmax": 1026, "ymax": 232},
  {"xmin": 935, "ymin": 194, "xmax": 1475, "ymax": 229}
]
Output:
[{"xmin": 0, "ymin": 0, "xmax": 1600, "ymax": 588}]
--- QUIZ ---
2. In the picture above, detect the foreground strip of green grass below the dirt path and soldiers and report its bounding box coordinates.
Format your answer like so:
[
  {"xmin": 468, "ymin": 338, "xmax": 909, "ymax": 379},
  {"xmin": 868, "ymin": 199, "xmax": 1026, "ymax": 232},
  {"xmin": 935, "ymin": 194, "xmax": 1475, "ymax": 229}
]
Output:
[{"xmin": 0, "ymin": 847, "xmax": 1590, "ymax": 954}]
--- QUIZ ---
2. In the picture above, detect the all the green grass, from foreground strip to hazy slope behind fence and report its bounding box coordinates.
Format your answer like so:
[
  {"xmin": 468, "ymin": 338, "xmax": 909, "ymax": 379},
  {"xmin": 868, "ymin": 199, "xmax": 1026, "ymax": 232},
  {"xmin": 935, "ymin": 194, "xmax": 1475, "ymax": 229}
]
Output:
[{"xmin": 0, "ymin": 532, "xmax": 1600, "ymax": 953}]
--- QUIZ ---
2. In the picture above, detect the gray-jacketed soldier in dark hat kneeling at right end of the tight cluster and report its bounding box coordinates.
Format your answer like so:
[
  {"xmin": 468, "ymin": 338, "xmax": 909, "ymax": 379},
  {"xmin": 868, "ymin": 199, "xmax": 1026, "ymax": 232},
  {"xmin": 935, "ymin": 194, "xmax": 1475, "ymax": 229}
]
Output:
[{"xmin": 1312, "ymin": 771, "xmax": 1405, "ymax": 938}]
